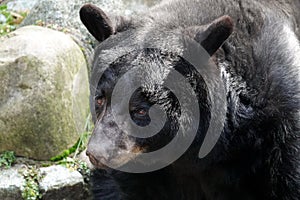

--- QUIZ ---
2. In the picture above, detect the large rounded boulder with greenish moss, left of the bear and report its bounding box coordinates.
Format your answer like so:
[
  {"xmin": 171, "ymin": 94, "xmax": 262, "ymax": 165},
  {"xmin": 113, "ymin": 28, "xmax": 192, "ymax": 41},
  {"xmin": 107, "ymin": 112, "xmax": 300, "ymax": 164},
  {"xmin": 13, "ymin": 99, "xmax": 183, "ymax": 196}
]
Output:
[{"xmin": 0, "ymin": 26, "xmax": 89, "ymax": 160}]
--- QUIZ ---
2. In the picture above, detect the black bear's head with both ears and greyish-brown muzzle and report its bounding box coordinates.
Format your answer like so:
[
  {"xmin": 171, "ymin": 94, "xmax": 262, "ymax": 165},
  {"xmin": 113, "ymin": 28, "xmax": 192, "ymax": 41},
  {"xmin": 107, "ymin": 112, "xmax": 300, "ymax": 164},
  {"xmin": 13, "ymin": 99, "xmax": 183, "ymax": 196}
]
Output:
[{"xmin": 80, "ymin": 4, "xmax": 233, "ymax": 171}]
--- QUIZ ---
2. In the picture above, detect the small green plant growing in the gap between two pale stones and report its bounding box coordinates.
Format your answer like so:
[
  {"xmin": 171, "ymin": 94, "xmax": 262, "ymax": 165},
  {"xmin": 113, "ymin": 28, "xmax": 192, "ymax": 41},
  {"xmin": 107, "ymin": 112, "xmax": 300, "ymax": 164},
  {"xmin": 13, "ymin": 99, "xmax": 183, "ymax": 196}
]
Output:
[{"xmin": 22, "ymin": 166, "xmax": 42, "ymax": 200}]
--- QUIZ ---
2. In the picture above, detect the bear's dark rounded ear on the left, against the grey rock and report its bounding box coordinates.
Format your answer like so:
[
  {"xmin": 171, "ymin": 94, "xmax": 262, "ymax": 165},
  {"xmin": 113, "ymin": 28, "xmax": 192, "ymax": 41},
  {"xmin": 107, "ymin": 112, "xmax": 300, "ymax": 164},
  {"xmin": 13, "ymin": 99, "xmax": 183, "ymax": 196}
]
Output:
[{"xmin": 79, "ymin": 4, "xmax": 114, "ymax": 42}]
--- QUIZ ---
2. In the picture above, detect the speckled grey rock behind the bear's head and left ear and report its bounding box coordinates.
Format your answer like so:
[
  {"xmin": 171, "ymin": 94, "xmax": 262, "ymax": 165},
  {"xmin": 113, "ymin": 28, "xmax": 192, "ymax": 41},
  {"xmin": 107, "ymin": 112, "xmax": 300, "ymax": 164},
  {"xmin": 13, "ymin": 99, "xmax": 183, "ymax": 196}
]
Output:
[{"xmin": 21, "ymin": 0, "xmax": 159, "ymax": 71}]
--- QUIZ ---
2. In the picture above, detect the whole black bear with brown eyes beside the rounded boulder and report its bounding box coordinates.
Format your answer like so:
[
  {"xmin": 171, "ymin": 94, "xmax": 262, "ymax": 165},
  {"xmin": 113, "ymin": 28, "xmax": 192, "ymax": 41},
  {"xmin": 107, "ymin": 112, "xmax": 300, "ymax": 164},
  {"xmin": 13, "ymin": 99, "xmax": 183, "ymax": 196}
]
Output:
[{"xmin": 80, "ymin": 0, "xmax": 300, "ymax": 200}]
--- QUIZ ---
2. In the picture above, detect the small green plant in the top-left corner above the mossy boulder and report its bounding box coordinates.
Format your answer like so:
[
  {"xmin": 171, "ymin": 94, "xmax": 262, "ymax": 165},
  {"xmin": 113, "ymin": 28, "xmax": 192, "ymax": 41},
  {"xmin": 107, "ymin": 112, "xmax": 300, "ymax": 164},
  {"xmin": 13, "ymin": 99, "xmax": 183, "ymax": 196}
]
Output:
[{"xmin": 0, "ymin": 4, "xmax": 28, "ymax": 36}]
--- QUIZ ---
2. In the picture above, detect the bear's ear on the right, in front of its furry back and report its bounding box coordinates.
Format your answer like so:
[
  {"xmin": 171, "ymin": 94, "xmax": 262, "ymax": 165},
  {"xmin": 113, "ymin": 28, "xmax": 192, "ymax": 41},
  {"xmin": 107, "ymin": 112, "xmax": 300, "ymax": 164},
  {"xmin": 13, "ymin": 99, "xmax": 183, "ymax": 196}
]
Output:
[{"xmin": 186, "ymin": 15, "xmax": 234, "ymax": 56}]
